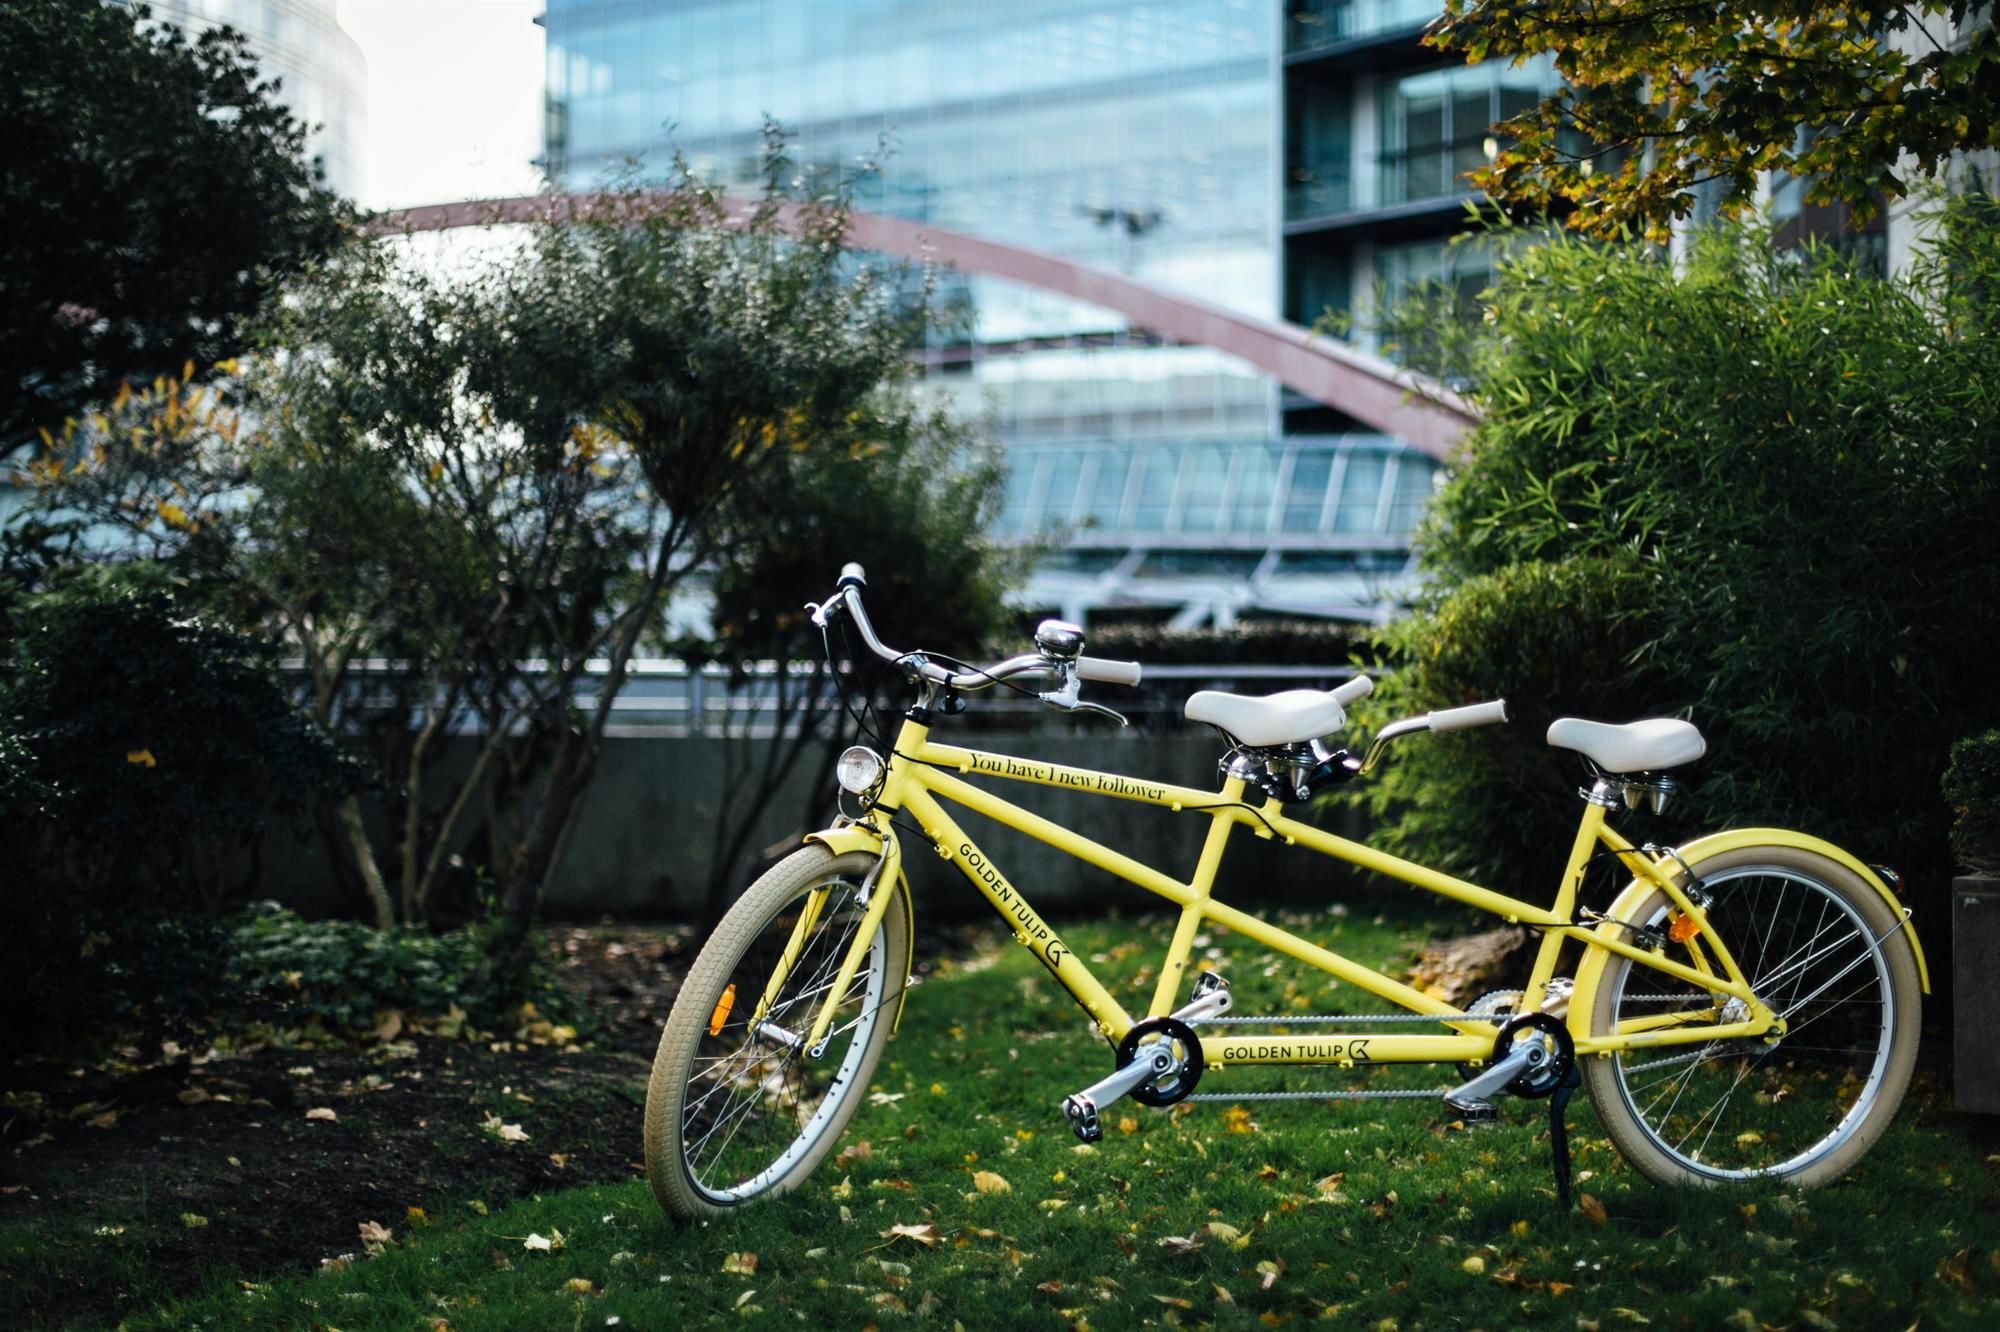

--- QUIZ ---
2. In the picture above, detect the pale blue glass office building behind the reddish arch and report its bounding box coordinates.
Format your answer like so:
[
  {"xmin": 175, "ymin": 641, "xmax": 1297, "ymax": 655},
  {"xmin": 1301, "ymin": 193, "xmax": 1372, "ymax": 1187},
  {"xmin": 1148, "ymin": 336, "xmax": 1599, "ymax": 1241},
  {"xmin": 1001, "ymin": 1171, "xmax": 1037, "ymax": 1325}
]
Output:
[{"xmin": 542, "ymin": 0, "xmax": 1436, "ymax": 624}]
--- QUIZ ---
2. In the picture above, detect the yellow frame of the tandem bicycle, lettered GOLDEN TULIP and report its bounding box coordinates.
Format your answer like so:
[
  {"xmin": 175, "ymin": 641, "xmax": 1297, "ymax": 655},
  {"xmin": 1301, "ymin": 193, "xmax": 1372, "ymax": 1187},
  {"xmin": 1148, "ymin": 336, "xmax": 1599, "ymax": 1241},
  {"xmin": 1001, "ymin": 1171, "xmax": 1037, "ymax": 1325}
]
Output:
[{"xmin": 806, "ymin": 720, "xmax": 1930, "ymax": 1068}]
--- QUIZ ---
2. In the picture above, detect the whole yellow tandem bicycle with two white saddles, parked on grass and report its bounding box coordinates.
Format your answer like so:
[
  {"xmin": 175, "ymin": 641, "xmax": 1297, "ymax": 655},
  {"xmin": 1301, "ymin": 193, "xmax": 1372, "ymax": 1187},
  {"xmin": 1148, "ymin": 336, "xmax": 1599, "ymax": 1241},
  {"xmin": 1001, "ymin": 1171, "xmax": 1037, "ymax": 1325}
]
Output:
[{"xmin": 646, "ymin": 564, "xmax": 1930, "ymax": 1218}]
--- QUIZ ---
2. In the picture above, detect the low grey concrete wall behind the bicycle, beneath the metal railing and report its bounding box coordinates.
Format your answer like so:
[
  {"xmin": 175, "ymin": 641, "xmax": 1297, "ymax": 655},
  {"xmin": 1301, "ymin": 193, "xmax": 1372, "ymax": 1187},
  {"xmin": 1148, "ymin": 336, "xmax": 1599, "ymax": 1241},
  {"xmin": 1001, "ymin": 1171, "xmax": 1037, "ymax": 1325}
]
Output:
[{"xmin": 260, "ymin": 734, "xmax": 1384, "ymax": 918}]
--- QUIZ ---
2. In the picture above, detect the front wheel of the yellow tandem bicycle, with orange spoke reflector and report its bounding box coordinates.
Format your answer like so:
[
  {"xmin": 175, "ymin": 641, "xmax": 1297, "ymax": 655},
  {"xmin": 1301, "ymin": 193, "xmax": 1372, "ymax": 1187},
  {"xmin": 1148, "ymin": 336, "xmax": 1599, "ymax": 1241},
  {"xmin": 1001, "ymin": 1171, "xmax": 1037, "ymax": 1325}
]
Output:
[{"xmin": 646, "ymin": 846, "xmax": 910, "ymax": 1220}]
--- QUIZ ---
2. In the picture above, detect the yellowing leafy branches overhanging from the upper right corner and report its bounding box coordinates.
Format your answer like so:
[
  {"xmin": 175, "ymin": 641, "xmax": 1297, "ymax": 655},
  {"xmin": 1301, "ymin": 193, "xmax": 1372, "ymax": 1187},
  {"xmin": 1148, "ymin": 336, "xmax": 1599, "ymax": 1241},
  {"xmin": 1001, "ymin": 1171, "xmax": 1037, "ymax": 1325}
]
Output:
[{"xmin": 1426, "ymin": 0, "xmax": 2000, "ymax": 238}]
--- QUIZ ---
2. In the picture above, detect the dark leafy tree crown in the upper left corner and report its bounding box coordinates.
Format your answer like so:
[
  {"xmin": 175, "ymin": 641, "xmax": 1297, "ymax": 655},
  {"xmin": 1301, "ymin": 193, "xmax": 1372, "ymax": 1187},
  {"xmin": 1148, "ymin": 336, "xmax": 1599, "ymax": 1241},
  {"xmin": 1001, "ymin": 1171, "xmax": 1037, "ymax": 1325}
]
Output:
[{"xmin": 0, "ymin": 0, "xmax": 344, "ymax": 456}]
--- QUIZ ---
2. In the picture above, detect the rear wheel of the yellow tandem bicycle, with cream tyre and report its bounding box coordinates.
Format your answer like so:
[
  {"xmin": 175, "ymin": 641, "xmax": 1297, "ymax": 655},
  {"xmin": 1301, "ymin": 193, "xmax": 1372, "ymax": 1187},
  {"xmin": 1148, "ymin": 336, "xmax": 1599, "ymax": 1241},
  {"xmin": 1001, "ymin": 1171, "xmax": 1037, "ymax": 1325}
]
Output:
[{"xmin": 1580, "ymin": 846, "xmax": 1920, "ymax": 1186}]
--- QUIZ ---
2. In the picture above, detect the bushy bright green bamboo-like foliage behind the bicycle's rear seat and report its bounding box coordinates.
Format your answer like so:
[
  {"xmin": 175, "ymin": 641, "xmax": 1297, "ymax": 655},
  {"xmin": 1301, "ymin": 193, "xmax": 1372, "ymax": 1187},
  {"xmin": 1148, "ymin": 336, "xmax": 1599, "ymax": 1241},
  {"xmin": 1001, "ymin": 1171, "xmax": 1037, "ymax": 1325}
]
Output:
[{"xmin": 1364, "ymin": 198, "xmax": 2000, "ymax": 940}]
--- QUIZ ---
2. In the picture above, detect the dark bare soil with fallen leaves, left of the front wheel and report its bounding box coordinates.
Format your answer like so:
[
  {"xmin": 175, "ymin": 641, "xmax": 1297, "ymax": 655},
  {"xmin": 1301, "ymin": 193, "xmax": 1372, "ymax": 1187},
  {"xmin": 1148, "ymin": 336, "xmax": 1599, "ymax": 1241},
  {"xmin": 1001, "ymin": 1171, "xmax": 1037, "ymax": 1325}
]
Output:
[{"xmin": 0, "ymin": 926, "xmax": 692, "ymax": 1326}]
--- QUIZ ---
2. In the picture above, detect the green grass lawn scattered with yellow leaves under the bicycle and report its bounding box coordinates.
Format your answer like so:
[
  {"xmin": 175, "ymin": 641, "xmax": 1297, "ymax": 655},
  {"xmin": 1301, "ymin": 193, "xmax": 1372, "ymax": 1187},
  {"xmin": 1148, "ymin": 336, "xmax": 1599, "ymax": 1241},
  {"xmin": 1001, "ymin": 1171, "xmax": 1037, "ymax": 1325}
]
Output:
[{"xmin": 15, "ymin": 914, "xmax": 2000, "ymax": 1332}]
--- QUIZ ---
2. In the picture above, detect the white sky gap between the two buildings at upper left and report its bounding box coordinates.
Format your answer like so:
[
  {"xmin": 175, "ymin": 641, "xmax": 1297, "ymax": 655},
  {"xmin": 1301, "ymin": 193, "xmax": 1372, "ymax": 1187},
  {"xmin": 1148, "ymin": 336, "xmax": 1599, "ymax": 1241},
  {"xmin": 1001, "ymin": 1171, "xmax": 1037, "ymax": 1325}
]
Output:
[{"xmin": 338, "ymin": 0, "xmax": 542, "ymax": 208}]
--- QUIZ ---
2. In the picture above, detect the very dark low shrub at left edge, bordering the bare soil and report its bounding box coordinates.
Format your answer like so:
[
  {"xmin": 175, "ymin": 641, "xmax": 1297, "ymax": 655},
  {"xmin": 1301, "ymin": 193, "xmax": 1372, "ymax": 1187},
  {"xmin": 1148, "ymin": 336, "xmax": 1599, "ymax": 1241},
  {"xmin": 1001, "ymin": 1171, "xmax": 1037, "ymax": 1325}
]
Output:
[{"xmin": 0, "ymin": 570, "xmax": 362, "ymax": 1048}]
